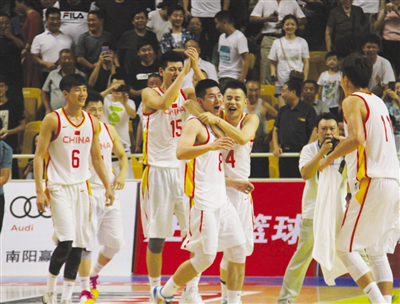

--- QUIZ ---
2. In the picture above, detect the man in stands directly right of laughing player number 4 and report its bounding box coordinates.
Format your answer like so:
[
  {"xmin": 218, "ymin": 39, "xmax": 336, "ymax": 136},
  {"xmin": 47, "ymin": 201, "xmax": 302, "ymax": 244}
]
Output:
[{"xmin": 243, "ymin": 80, "xmax": 278, "ymax": 177}]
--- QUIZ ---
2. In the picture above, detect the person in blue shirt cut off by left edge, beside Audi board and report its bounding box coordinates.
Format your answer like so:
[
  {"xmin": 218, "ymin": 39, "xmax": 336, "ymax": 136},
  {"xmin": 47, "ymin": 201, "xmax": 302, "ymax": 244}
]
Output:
[{"xmin": 0, "ymin": 118, "xmax": 13, "ymax": 234}]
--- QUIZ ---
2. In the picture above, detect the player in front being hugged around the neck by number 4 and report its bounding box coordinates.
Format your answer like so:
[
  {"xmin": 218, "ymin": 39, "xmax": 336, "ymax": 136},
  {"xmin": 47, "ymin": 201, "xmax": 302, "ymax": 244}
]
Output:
[{"xmin": 151, "ymin": 79, "xmax": 246, "ymax": 303}]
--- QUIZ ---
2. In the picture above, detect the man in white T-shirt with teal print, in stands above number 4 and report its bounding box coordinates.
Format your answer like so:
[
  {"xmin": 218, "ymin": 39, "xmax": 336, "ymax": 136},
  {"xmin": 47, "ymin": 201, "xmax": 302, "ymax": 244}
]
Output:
[{"xmin": 215, "ymin": 11, "xmax": 250, "ymax": 91}]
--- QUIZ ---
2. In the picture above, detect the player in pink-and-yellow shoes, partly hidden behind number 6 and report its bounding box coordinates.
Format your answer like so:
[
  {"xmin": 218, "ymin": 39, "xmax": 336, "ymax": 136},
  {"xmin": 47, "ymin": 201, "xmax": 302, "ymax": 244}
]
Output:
[{"xmin": 79, "ymin": 92, "xmax": 129, "ymax": 304}]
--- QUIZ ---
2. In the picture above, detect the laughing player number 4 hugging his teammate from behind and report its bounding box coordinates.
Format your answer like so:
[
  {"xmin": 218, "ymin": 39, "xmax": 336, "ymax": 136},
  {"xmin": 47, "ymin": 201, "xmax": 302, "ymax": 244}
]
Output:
[{"xmin": 185, "ymin": 80, "xmax": 259, "ymax": 303}]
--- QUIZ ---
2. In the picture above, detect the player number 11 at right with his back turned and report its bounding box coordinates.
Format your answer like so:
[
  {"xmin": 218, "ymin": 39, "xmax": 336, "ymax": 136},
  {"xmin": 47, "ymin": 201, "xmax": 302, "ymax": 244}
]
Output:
[{"xmin": 319, "ymin": 55, "xmax": 400, "ymax": 304}]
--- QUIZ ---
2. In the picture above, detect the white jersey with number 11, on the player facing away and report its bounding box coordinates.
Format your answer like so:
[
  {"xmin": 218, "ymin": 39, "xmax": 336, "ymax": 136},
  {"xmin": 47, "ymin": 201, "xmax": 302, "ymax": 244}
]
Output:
[{"xmin": 344, "ymin": 92, "xmax": 399, "ymax": 193}]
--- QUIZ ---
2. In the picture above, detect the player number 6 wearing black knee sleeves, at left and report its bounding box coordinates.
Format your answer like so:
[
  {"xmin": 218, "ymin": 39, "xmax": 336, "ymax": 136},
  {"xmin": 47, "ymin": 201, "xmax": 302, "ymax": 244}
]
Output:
[{"xmin": 34, "ymin": 74, "xmax": 114, "ymax": 304}]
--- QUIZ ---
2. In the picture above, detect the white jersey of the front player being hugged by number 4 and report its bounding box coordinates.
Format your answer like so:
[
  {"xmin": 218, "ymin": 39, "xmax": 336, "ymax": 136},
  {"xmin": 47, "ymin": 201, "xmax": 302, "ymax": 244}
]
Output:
[{"xmin": 184, "ymin": 116, "xmax": 227, "ymax": 211}]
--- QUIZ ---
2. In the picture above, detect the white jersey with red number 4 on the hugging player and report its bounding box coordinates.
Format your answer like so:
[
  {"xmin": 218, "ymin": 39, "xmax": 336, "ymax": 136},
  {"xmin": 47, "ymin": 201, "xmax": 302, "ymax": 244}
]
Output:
[{"xmin": 222, "ymin": 113, "xmax": 254, "ymax": 180}]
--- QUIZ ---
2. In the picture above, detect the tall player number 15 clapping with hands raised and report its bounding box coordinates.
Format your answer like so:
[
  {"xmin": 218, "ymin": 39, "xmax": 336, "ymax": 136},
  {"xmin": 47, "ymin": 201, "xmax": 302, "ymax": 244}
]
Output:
[{"xmin": 141, "ymin": 48, "xmax": 204, "ymax": 300}]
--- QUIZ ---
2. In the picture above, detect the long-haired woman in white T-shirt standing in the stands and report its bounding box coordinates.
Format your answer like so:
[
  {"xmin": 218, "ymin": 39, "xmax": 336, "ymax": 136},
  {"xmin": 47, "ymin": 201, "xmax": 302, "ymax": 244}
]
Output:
[{"xmin": 268, "ymin": 15, "xmax": 310, "ymax": 106}]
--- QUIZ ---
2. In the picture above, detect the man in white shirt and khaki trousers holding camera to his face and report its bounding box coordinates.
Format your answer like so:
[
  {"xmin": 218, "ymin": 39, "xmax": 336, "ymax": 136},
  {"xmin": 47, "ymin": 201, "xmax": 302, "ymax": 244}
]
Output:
[{"xmin": 277, "ymin": 113, "xmax": 345, "ymax": 304}]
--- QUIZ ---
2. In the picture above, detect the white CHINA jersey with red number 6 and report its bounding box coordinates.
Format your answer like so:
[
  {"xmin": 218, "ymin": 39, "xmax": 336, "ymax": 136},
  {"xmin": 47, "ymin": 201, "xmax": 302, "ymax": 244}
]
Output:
[{"xmin": 46, "ymin": 108, "xmax": 94, "ymax": 186}]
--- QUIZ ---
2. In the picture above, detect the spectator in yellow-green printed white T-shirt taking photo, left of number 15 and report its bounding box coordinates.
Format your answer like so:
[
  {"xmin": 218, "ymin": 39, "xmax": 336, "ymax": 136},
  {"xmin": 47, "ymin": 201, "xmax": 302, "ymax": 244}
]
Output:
[{"xmin": 101, "ymin": 74, "xmax": 136, "ymax": 178}]
